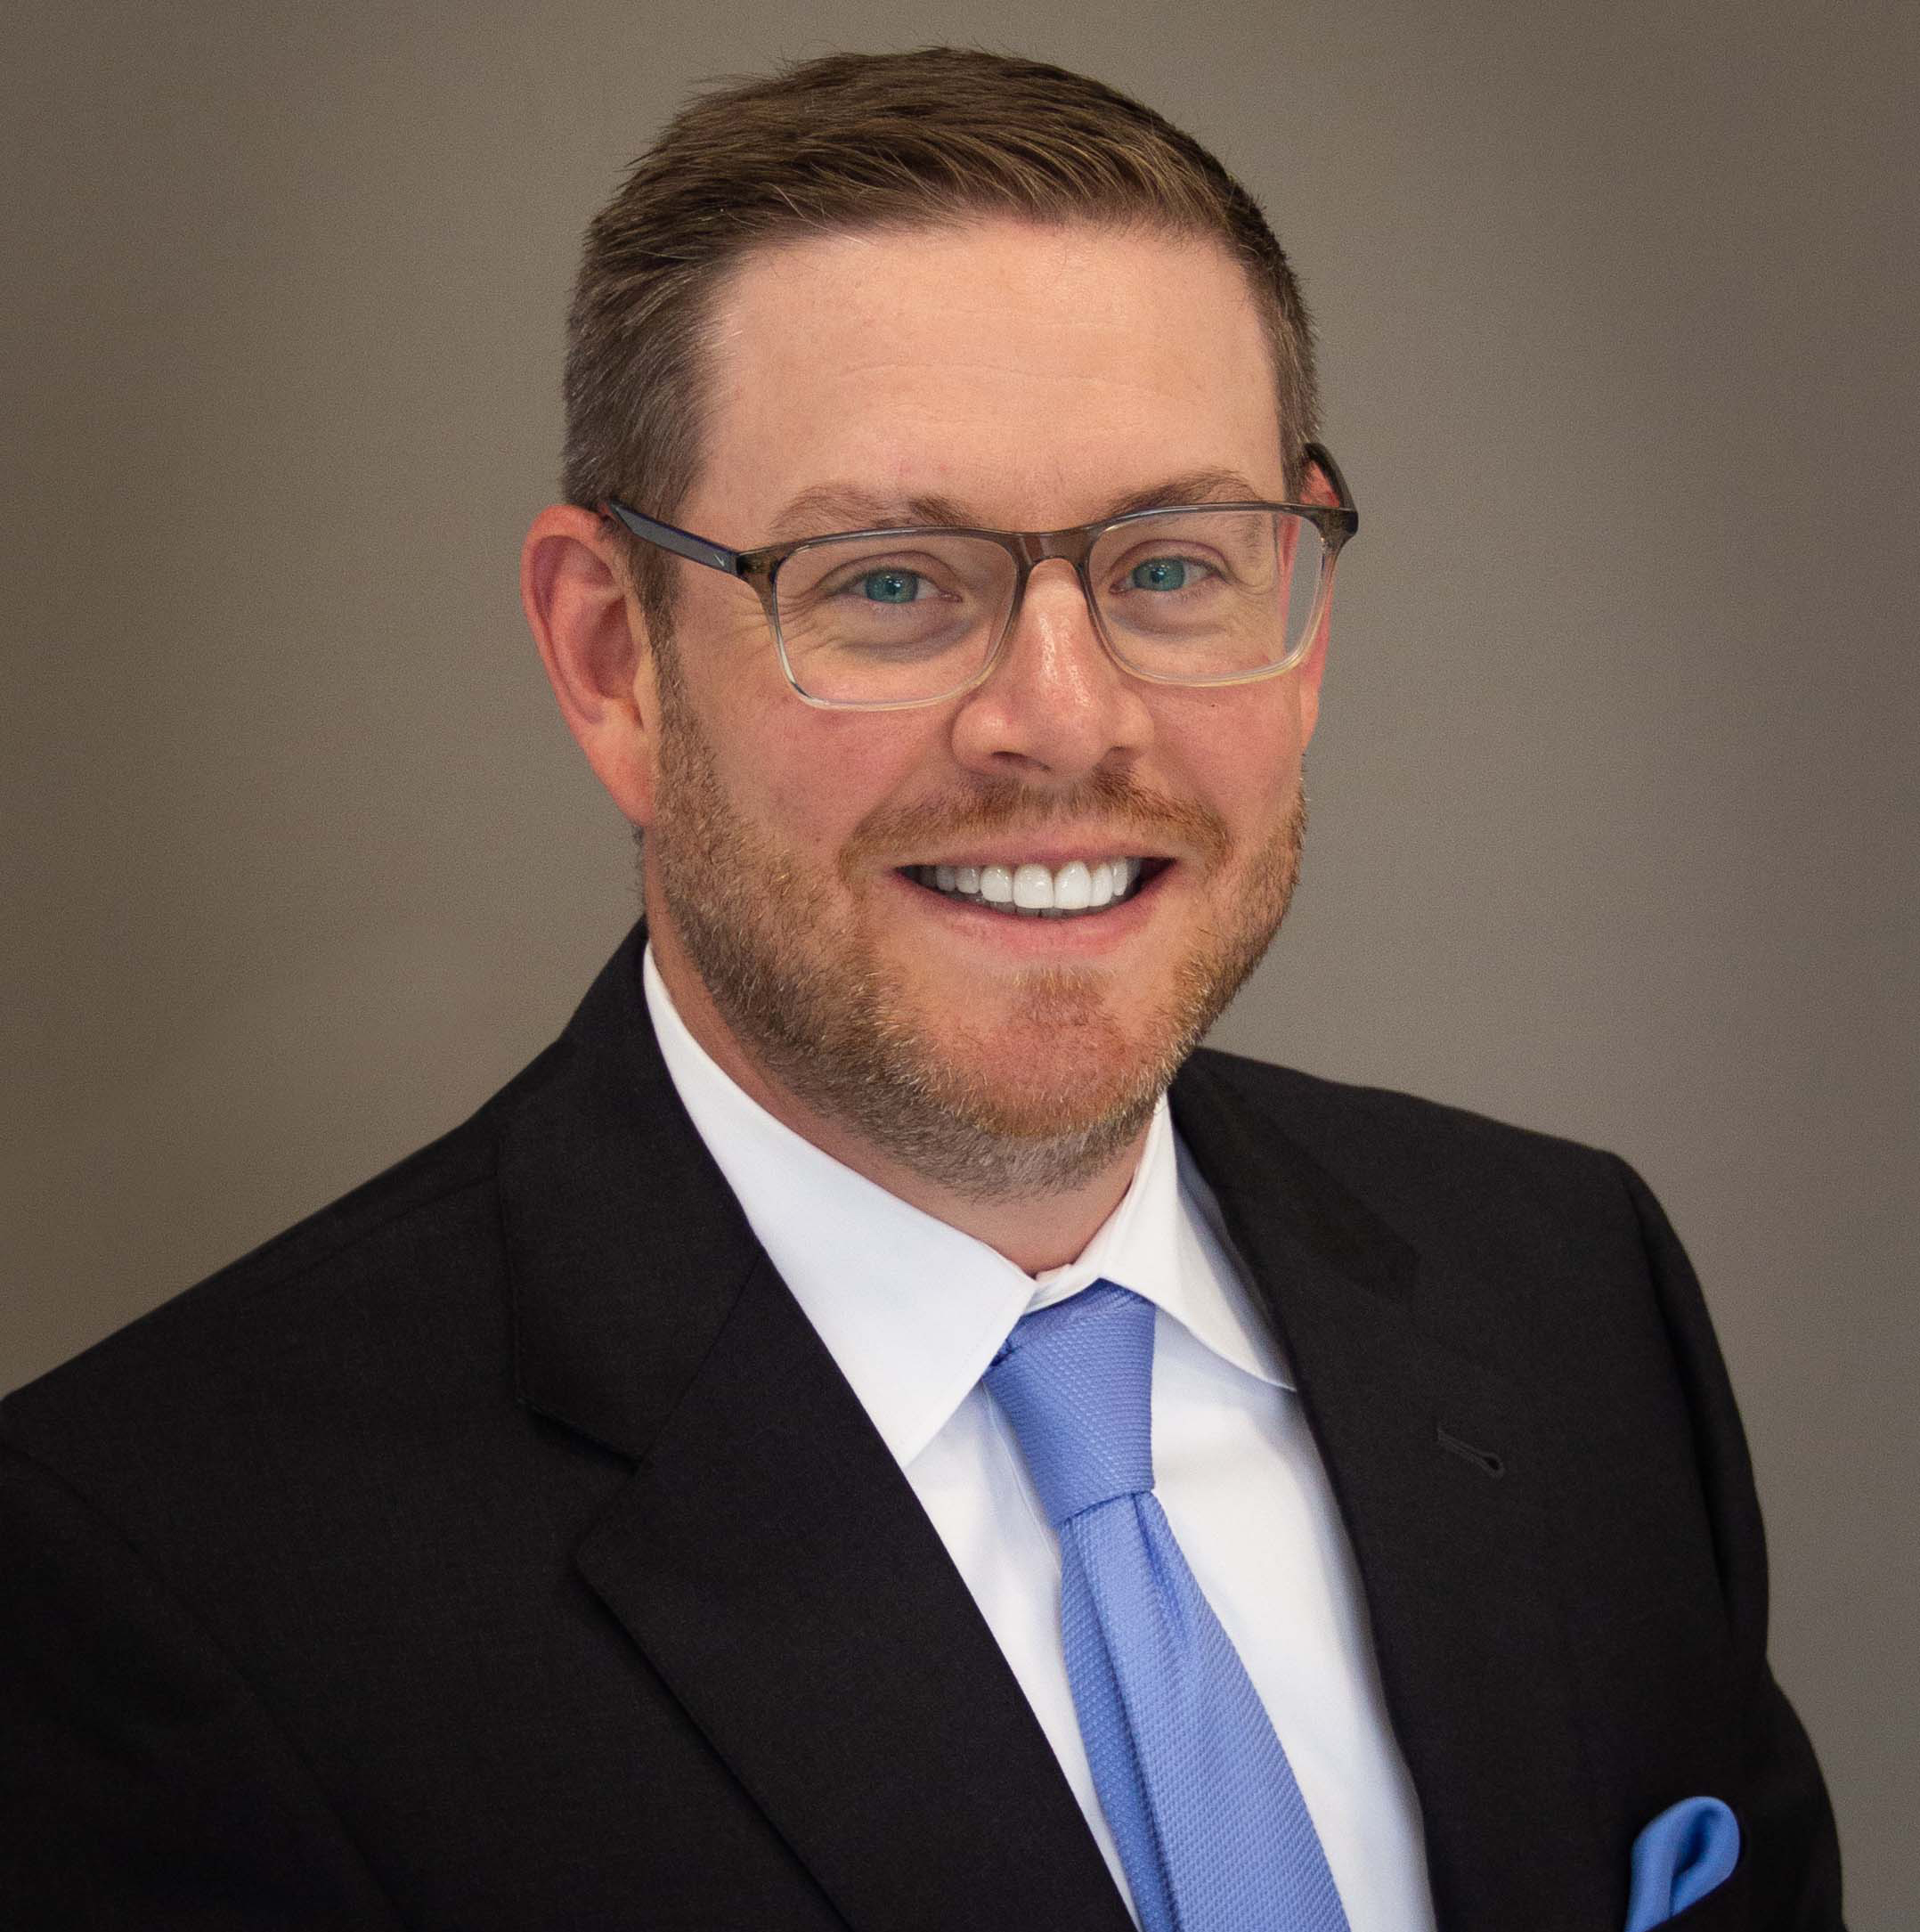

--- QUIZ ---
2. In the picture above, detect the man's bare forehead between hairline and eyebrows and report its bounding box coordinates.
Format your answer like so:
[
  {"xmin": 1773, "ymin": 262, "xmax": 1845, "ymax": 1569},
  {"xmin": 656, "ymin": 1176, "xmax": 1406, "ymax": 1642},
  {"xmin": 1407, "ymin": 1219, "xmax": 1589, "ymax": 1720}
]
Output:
[{"xmin": 687, "ymin": 220, "xmax": 1282, "ymax": 542}]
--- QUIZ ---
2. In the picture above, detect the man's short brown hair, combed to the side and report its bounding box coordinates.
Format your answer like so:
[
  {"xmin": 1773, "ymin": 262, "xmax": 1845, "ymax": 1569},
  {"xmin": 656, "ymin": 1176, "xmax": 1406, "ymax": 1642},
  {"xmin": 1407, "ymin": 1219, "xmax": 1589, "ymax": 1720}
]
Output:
[{"xmin": 562, "ymin": 46, "xmax": 1317, "ymax": 622}]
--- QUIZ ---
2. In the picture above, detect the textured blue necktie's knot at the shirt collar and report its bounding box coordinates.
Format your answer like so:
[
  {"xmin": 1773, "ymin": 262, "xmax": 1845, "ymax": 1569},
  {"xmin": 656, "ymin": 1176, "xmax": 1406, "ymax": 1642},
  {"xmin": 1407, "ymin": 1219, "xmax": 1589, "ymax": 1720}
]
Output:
[{"xmin": 985, "ymin": 1281, "xmax": 1153, "ymax": 1527}]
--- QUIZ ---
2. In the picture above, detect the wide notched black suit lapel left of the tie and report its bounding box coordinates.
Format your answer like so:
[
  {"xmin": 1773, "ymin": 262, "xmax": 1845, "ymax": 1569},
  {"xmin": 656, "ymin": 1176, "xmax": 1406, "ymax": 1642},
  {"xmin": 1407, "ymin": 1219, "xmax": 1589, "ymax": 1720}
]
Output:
[{"xmin": 500, "ymin": 933, "xmax": 1128, "ymax": 1932}]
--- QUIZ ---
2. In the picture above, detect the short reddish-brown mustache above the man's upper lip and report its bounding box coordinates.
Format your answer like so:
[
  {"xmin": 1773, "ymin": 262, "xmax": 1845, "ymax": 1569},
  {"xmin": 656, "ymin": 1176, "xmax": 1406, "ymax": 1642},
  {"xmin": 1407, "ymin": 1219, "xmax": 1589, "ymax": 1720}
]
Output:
[{"xmin": 841, "ymin": 773, "xmax": 1233, "ymax": 876}]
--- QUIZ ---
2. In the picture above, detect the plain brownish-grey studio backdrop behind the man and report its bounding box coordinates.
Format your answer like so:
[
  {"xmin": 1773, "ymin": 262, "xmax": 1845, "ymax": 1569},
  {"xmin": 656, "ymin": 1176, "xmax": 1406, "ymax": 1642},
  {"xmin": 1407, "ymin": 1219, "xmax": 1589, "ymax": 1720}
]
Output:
[{"xmin": 0, "ymin": 0, "xmax": 1920, "ymax": 1932}]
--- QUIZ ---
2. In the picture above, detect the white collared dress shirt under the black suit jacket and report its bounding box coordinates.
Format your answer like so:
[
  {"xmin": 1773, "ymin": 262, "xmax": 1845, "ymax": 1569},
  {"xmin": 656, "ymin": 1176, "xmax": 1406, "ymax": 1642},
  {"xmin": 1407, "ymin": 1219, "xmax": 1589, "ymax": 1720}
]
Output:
[{"xmin": 643, "ymin": 949, "xmax": 1433, "ymax": 1932}]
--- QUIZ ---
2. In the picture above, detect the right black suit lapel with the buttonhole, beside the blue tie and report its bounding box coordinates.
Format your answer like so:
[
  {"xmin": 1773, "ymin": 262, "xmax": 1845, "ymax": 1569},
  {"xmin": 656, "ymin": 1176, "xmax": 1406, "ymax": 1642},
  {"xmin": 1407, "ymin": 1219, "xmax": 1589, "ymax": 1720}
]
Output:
[{"xmin": 1175, "ymin": 1055, "xmax": 1619, "ymax": 1926}]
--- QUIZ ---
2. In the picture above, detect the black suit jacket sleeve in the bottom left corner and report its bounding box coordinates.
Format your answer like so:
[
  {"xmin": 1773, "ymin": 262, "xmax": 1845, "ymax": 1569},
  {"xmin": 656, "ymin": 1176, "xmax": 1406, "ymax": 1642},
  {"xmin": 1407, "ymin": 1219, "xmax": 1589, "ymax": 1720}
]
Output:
[{"xmin": 0, "ymin": 1445, "xmax": 400, "ymax": 1932}]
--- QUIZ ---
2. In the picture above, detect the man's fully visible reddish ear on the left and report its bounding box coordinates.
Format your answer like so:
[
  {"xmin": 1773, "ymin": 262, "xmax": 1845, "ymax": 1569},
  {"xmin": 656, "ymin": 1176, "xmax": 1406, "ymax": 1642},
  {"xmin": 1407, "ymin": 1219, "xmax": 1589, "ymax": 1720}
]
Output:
[{"xmin": 519, "ymin": 502, "xmax": 659, "ymax": 825}]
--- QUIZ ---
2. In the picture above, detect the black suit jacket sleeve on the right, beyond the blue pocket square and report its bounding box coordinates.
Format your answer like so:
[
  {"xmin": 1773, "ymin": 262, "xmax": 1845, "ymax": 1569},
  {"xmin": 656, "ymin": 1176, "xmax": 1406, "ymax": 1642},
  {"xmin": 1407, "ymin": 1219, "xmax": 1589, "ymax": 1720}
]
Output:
[{"xmin": 1621, "ymin": 1163, "xmax": 1841, "ymax": 1932}]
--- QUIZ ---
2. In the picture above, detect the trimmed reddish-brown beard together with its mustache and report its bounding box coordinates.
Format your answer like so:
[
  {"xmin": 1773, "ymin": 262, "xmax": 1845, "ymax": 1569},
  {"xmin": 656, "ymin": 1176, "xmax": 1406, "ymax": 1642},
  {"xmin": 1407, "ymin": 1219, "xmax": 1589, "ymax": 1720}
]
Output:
[{"xmin": 645, "ymin": 668, "xmax": 1306, "ymax": 1200}]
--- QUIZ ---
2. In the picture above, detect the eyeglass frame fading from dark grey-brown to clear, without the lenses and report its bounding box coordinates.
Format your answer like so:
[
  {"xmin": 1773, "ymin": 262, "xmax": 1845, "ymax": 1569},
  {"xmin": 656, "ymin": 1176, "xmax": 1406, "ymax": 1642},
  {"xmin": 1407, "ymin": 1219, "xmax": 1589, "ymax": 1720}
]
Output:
[{"xmin": 598, "ymin": 443, "xmax": 1360, "ymax": 711}]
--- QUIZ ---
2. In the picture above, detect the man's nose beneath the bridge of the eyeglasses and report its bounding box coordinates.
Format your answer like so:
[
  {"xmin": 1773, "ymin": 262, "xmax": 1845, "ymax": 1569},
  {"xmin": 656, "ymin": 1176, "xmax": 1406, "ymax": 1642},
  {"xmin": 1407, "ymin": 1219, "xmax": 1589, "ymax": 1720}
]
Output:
[{"xmin": 952, "ymin": 558, "xmax": 1153, "ymax": 785}]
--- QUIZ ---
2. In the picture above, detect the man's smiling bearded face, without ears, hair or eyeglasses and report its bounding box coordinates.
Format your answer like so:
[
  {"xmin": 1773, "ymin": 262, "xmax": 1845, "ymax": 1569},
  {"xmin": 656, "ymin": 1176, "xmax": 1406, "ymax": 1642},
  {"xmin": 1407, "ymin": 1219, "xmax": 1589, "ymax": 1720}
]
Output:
[{"xmin": 645, "ymin": 220, "xmax": 1322, "ymax": 1196}]
